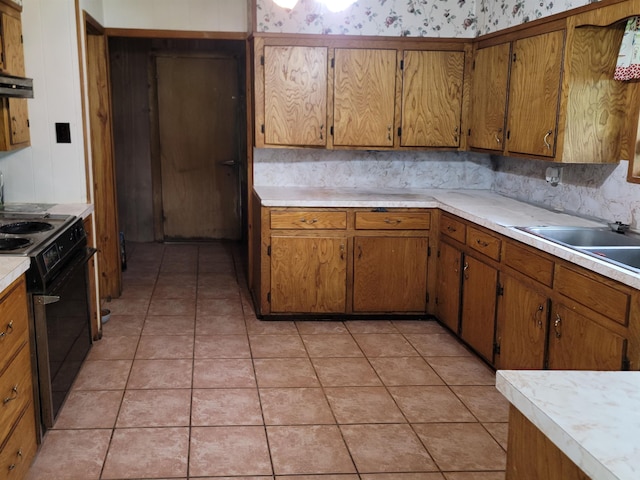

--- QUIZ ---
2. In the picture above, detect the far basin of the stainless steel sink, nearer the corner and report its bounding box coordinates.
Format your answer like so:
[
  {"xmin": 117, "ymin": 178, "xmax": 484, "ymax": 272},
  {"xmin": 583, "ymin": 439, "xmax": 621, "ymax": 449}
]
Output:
[{"xmin": 522, "ymin": 227, "xmax": 640, "ymax": 248}]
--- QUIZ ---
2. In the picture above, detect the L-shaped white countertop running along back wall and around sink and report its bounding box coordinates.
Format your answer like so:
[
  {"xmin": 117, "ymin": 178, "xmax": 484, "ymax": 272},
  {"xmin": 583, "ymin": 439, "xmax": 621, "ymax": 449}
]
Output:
[{"xmin": 254, "ymin": 186, "xmax": 640, "ymax": 289}]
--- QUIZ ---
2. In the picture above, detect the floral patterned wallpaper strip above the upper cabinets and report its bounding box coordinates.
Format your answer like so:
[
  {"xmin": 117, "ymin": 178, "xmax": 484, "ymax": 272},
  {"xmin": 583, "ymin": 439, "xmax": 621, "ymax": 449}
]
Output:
[{"xmin": 256, "ymin": 0, "xmax": 597, "ymax": 38}]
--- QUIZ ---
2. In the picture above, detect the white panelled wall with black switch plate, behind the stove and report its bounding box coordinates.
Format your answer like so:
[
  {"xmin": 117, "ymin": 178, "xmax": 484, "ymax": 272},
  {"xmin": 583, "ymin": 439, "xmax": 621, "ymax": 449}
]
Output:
[{"xmin": 0, "ymin": 0, "xmax": 86, "ymax": 203}]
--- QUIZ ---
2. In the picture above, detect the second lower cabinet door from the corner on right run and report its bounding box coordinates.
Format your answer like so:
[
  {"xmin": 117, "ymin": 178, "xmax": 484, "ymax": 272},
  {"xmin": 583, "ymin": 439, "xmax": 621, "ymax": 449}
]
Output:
[{"xmin": 460, "ymin": 256, "xmax": 498, "ymax": 363}]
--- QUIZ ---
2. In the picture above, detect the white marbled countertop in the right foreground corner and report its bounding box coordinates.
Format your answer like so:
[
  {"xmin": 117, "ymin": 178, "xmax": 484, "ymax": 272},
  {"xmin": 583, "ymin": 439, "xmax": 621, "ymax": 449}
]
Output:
[{"xmin": 496, "ymin": 370, "xmax": 640, "ymax": 480}]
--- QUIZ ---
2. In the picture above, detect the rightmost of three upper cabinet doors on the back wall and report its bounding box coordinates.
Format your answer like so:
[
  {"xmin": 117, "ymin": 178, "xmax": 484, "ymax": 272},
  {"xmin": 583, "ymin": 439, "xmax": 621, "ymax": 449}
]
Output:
[{"xmin": 400, "ymin": 51, "xmax": 462, "ymax": 147}]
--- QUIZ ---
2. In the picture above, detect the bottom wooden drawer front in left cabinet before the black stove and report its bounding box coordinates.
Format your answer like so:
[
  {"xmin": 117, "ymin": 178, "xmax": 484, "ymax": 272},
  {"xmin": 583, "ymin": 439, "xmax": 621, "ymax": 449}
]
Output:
[{"xmin": 0, "ymin": 403, "xmax": 37, "ymax": 480}]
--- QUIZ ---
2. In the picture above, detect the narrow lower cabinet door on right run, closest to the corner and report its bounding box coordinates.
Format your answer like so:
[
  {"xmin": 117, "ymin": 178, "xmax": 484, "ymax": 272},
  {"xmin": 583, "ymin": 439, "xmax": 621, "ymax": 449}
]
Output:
[{"xmin": 436, "ymin": 242, "xmax": 462, "ymax": 333}]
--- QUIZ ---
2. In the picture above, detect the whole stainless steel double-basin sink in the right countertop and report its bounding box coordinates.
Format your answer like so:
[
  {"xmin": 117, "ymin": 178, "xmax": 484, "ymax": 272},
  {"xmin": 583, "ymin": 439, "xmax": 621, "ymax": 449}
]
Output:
[{"xmin": 518, "ymin": 227, "xmax": 640, "ymax": 273}]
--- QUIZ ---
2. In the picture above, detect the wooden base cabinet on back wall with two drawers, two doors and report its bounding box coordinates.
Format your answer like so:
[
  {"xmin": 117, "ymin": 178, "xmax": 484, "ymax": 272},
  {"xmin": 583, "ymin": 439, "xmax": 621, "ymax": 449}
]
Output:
[{"xmin": 251, "ymin": 199, "xmax": 431, "ymax": 317}]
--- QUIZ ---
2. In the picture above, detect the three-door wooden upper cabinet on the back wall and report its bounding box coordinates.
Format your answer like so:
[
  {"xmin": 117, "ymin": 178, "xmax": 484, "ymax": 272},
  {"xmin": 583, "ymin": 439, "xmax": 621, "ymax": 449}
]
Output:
[{"xmin": 253, "ymin": 35, "xmax": 471, "ymax": 150}]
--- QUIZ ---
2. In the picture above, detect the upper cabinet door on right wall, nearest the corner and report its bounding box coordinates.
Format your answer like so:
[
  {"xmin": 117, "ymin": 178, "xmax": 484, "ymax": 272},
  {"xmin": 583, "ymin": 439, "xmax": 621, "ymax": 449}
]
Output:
[{"xmin": 469, "ymin": 43, "xmax": 511, "ymax": 151}]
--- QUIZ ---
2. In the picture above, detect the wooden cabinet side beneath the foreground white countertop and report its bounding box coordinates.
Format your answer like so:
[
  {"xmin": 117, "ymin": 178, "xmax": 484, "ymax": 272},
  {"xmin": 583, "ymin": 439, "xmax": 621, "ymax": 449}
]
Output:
[{"xmin": 506, "ymin": 405, "xmax": 590, "ymax": 480}]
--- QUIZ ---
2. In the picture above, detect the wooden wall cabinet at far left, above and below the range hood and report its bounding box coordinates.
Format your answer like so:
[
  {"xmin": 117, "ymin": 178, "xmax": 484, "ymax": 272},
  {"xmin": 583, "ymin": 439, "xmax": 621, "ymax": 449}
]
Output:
[{"xmin": 0, "ymin": 3, "xmax": 30, "ymax": 151}]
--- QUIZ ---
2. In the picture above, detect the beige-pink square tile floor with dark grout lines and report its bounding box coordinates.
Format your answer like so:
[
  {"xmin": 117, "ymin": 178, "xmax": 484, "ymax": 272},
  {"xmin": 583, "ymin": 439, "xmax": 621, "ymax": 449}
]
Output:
[{"xmin": 28, "ymin": 243, "xmax": 508, "ymax": 480}]
